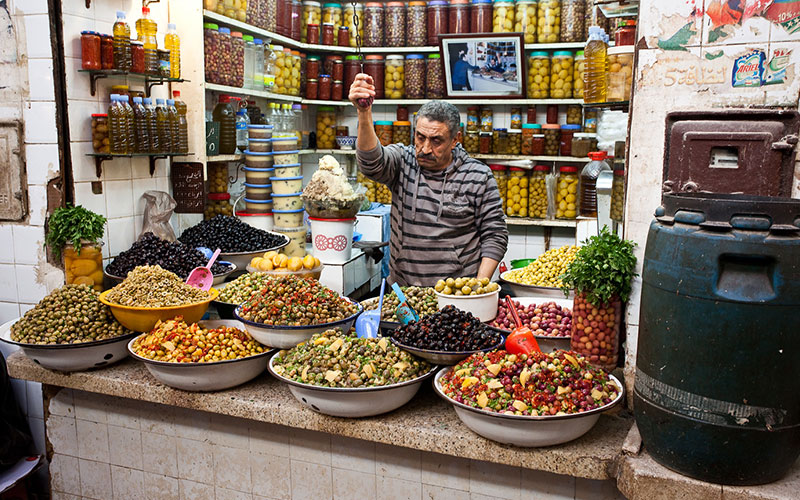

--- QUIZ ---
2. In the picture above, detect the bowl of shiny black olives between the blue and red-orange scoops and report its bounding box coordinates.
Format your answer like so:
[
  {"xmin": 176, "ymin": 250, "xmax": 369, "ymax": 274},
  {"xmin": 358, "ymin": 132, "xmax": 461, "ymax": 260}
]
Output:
[{"xmin": 391, "ymin": 305, "xmax": 505, "ymax": 365}]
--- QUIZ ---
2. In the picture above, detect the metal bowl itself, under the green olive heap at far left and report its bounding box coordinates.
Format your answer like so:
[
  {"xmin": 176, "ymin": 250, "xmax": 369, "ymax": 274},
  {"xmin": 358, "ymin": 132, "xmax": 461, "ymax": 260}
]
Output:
[{"xmin": 0, "ymin": 318, "xmax": 137, "ymax": 372}]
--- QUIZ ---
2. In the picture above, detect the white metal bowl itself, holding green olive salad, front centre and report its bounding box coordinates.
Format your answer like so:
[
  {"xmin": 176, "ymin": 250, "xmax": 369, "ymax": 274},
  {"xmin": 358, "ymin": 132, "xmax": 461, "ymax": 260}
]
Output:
[{"xmin": 268, "ymin": 357, "xmax": 439, "ymax": 418}]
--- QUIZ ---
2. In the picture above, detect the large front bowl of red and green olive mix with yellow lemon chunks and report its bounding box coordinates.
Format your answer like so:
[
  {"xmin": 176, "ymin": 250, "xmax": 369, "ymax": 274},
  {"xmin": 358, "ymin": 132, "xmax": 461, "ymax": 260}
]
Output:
[{"xmin": 433, "ymin": 350, "xmax": 624, "ymax": 447}]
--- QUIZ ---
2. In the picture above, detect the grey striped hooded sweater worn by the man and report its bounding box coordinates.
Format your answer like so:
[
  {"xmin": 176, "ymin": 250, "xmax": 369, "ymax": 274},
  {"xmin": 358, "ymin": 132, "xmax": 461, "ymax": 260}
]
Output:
[{"xmin": 356, "ymin": 144, "xmax": 508, "ymax": 286}]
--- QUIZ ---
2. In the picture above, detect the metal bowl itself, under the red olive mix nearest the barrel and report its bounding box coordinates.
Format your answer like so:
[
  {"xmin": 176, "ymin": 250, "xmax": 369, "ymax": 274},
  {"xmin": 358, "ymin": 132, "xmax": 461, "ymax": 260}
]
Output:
[{"xmin": 433, "ymin": 367, "xmax": 625, "ymax": 448}]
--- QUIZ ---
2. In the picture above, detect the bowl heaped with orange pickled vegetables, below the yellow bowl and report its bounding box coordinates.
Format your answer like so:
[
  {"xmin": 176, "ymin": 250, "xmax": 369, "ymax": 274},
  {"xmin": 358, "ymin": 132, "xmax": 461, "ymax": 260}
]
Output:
[{"xmin": 128, "ymin": 317, "xmax": 274, "ymax": 391}]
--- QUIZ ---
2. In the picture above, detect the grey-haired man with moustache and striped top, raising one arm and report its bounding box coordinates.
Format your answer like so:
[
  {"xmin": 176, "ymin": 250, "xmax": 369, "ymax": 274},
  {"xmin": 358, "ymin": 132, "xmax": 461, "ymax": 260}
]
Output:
[{"xmin": 349, "ymin": 74, "xmax": 508, "ymax": 286}]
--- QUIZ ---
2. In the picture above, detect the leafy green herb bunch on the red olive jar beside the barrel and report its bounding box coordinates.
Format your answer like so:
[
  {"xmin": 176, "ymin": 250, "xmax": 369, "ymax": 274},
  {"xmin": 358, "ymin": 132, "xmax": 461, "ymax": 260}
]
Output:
[{"xmin": 560, "ymin": 227, "xmax": 636, "ymax": 305}]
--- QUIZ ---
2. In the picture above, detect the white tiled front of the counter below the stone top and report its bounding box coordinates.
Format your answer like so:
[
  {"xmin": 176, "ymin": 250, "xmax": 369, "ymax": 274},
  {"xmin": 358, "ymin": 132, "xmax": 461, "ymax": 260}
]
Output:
[{"xmin": 47, "ymin": 389, "xmax": 622, "ymax": 500}]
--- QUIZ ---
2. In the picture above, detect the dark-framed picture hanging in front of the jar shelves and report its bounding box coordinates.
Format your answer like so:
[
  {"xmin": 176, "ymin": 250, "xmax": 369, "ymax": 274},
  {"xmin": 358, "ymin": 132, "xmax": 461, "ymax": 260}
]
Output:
[{"xmin": 439, "ymin": 33, "xmax": 527, "ymax": 99}]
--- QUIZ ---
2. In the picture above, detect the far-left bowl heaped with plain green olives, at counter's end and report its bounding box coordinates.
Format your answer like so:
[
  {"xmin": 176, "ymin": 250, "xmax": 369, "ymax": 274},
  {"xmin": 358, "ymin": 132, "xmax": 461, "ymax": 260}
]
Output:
[{"xmin": 0, "ymin": 285, "xmax": 136, "ymax": 372}]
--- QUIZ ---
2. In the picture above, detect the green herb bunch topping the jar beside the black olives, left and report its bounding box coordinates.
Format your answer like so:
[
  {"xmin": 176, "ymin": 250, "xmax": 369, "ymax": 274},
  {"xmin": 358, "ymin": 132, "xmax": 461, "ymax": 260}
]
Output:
[{"xmin": 45, "ymin": 204, "xmax": 106, "ymax": 257}]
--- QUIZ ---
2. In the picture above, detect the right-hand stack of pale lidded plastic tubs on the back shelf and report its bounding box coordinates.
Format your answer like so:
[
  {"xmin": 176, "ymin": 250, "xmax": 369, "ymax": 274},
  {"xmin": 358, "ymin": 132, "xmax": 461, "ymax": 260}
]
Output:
[{"xmin": 270, "ymin": 132, "xmax": 306, "ymax": 257}]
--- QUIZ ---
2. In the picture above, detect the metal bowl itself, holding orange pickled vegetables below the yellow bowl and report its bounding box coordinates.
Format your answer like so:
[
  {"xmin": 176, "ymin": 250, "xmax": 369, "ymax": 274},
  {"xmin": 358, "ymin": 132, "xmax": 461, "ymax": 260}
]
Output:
[{"xmin": 127, "ymin": 320, "xmax": 276, "ymax": 392}]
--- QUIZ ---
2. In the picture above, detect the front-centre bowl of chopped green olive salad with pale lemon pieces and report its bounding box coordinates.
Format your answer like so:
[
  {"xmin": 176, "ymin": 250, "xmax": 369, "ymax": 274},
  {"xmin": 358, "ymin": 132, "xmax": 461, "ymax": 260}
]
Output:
[{"xmin": 269, "ymin": 329, "xmax": 436, "ymax": 418}]
